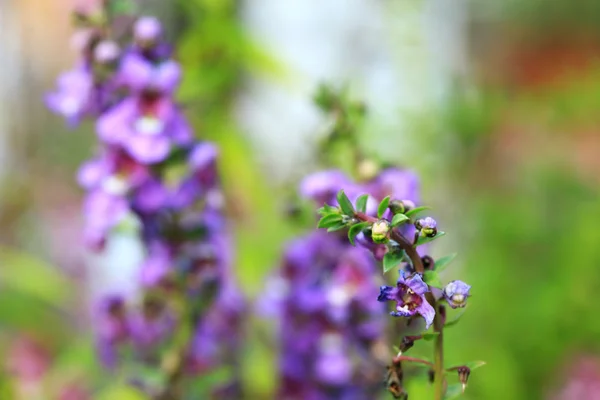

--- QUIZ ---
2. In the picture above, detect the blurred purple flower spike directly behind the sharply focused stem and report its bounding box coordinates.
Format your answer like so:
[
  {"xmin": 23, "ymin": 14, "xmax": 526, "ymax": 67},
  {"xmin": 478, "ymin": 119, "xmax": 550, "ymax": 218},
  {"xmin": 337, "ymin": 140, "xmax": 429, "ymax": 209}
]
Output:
[{"xmin": 261, "ymin": 168, "xmax": 419, "ymax": 399}]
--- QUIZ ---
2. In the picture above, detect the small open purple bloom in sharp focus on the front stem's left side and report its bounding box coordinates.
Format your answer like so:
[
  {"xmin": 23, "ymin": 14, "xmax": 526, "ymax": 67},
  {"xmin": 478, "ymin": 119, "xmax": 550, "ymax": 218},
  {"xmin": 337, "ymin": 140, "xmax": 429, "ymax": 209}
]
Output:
[{"xmin": 377, "ymin": 270, "xmax": 435, "ymax": 328}]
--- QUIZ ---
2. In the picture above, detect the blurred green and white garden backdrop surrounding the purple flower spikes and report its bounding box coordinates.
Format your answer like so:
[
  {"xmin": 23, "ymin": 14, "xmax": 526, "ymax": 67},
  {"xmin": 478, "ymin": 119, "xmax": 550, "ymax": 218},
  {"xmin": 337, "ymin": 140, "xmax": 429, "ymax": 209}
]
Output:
[{"xmin": 0, "ymin": 0, "xmax": 600, "ymax": 400}]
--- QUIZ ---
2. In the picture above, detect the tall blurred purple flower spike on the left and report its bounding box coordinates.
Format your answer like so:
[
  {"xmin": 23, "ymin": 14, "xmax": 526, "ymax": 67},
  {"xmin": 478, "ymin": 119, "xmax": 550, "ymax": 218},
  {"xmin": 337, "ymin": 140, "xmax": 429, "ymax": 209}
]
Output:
[{"xmin": 46, "ymin": 10, "xmax": 245, "ymax": 382}]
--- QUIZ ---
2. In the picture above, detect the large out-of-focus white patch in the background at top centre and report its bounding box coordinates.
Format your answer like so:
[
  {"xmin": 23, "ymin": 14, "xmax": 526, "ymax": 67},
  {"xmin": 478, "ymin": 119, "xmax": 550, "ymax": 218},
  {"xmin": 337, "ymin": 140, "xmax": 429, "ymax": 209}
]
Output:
[{"xmin": 237, "ymin": 0, "xmax": 467, "ymax": 180}]
